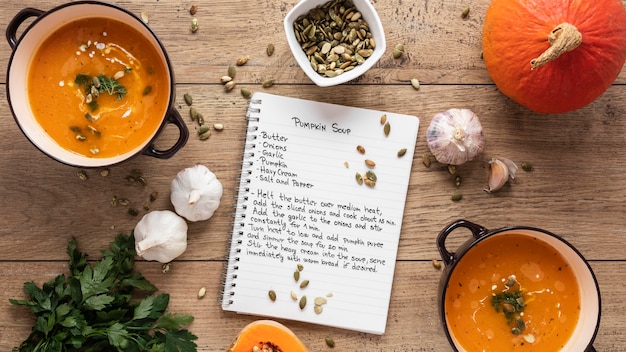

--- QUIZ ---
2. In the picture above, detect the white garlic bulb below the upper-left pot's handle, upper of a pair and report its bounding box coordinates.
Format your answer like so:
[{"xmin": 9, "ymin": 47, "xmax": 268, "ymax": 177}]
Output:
[{"xmin": 170, "ymin": 165, "xmax": 223, "ymax": 221}]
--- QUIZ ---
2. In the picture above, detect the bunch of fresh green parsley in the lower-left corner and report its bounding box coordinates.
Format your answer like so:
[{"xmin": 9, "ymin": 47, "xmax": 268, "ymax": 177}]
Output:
[{"xmin": 9, "ymin": 233, "xmax": 197, "ymax": 352}]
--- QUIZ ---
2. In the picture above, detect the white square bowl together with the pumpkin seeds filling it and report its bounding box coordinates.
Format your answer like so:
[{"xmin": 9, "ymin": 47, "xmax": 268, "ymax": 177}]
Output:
[{"xmin": 284, "ymin": 0, "xmax": 386, "ymax": 87}]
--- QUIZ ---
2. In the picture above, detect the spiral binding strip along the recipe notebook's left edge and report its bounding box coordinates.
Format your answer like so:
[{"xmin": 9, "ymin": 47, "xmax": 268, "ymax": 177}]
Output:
[{"xmin": 219, "ymin": 98, "xmax": 262, "ymax": 306}]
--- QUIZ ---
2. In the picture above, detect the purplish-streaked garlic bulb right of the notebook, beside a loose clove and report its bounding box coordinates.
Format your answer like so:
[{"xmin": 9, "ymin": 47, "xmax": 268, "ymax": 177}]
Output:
[{"xmin": 426, "ymin": 109, "xmax": 485, "ymax": 165}]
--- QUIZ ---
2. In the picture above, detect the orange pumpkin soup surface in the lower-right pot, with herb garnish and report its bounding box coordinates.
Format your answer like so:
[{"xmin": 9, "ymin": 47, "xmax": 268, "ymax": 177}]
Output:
[{"xmin": 444, "ymin": 233, "xmax": 580, "ymax": 352}]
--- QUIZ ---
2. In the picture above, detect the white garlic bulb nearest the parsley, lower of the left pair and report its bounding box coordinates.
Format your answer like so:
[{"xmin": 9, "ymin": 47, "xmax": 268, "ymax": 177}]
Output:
[{"xmin": 134, "ymin": 210, "xmax": 187, "ymax": 263}]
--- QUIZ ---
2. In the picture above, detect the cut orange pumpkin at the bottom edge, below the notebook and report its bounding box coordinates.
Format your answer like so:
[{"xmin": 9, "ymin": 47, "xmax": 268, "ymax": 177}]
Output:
[{"xmin": 227, "ymin": 320, "xmax": 309, "ymax": 352}]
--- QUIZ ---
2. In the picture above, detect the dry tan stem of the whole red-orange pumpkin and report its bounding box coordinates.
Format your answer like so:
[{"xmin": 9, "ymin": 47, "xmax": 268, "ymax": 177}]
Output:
[{"xmin": 530, "ymin": 22, "xmax": 583, "ymax": 70}]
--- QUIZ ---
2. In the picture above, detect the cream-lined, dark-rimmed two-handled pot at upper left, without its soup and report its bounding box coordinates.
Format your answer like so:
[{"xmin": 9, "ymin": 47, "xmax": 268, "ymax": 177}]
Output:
[{"xmin": 6, "ymin": 0, "xmax": 189, "ymax": 167}]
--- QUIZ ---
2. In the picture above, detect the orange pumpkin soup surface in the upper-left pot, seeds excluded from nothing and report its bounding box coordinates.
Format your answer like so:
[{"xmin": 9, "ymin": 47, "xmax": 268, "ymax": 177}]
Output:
[{"xmin": 28, "ymin": 18, "xmax": 169, "ymax": 158}]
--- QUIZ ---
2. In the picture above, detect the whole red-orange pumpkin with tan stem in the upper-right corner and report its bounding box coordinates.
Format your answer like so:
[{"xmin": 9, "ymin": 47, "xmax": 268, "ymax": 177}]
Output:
[{"xmin": 482, "ymin": 0, "xmax": 626, "ymax": 113}]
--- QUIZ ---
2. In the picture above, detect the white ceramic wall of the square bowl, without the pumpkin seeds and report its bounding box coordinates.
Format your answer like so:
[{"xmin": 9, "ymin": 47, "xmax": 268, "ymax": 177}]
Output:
[{"xmin": 284, "ymin": 0, "xmax": 386, "ymax": 87}]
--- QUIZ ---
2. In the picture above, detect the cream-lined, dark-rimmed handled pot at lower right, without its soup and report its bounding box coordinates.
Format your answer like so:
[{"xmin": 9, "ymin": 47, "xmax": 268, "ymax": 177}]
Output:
[{"xmin": 438, "ymin": 220, "xmax": 602, "ymax": 352}]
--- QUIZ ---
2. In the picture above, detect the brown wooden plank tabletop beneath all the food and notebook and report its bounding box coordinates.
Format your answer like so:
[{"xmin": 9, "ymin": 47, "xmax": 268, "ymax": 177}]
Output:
[{"xmin": 0, "ymin": 0, "xmax": 626, "ymax": 351}]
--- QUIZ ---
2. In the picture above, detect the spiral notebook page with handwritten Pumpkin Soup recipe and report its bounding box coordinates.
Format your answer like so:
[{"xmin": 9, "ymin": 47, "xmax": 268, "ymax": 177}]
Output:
[{"xmin": 221, "ymin": 93, "xmax": 419, "ymax": 334}]
